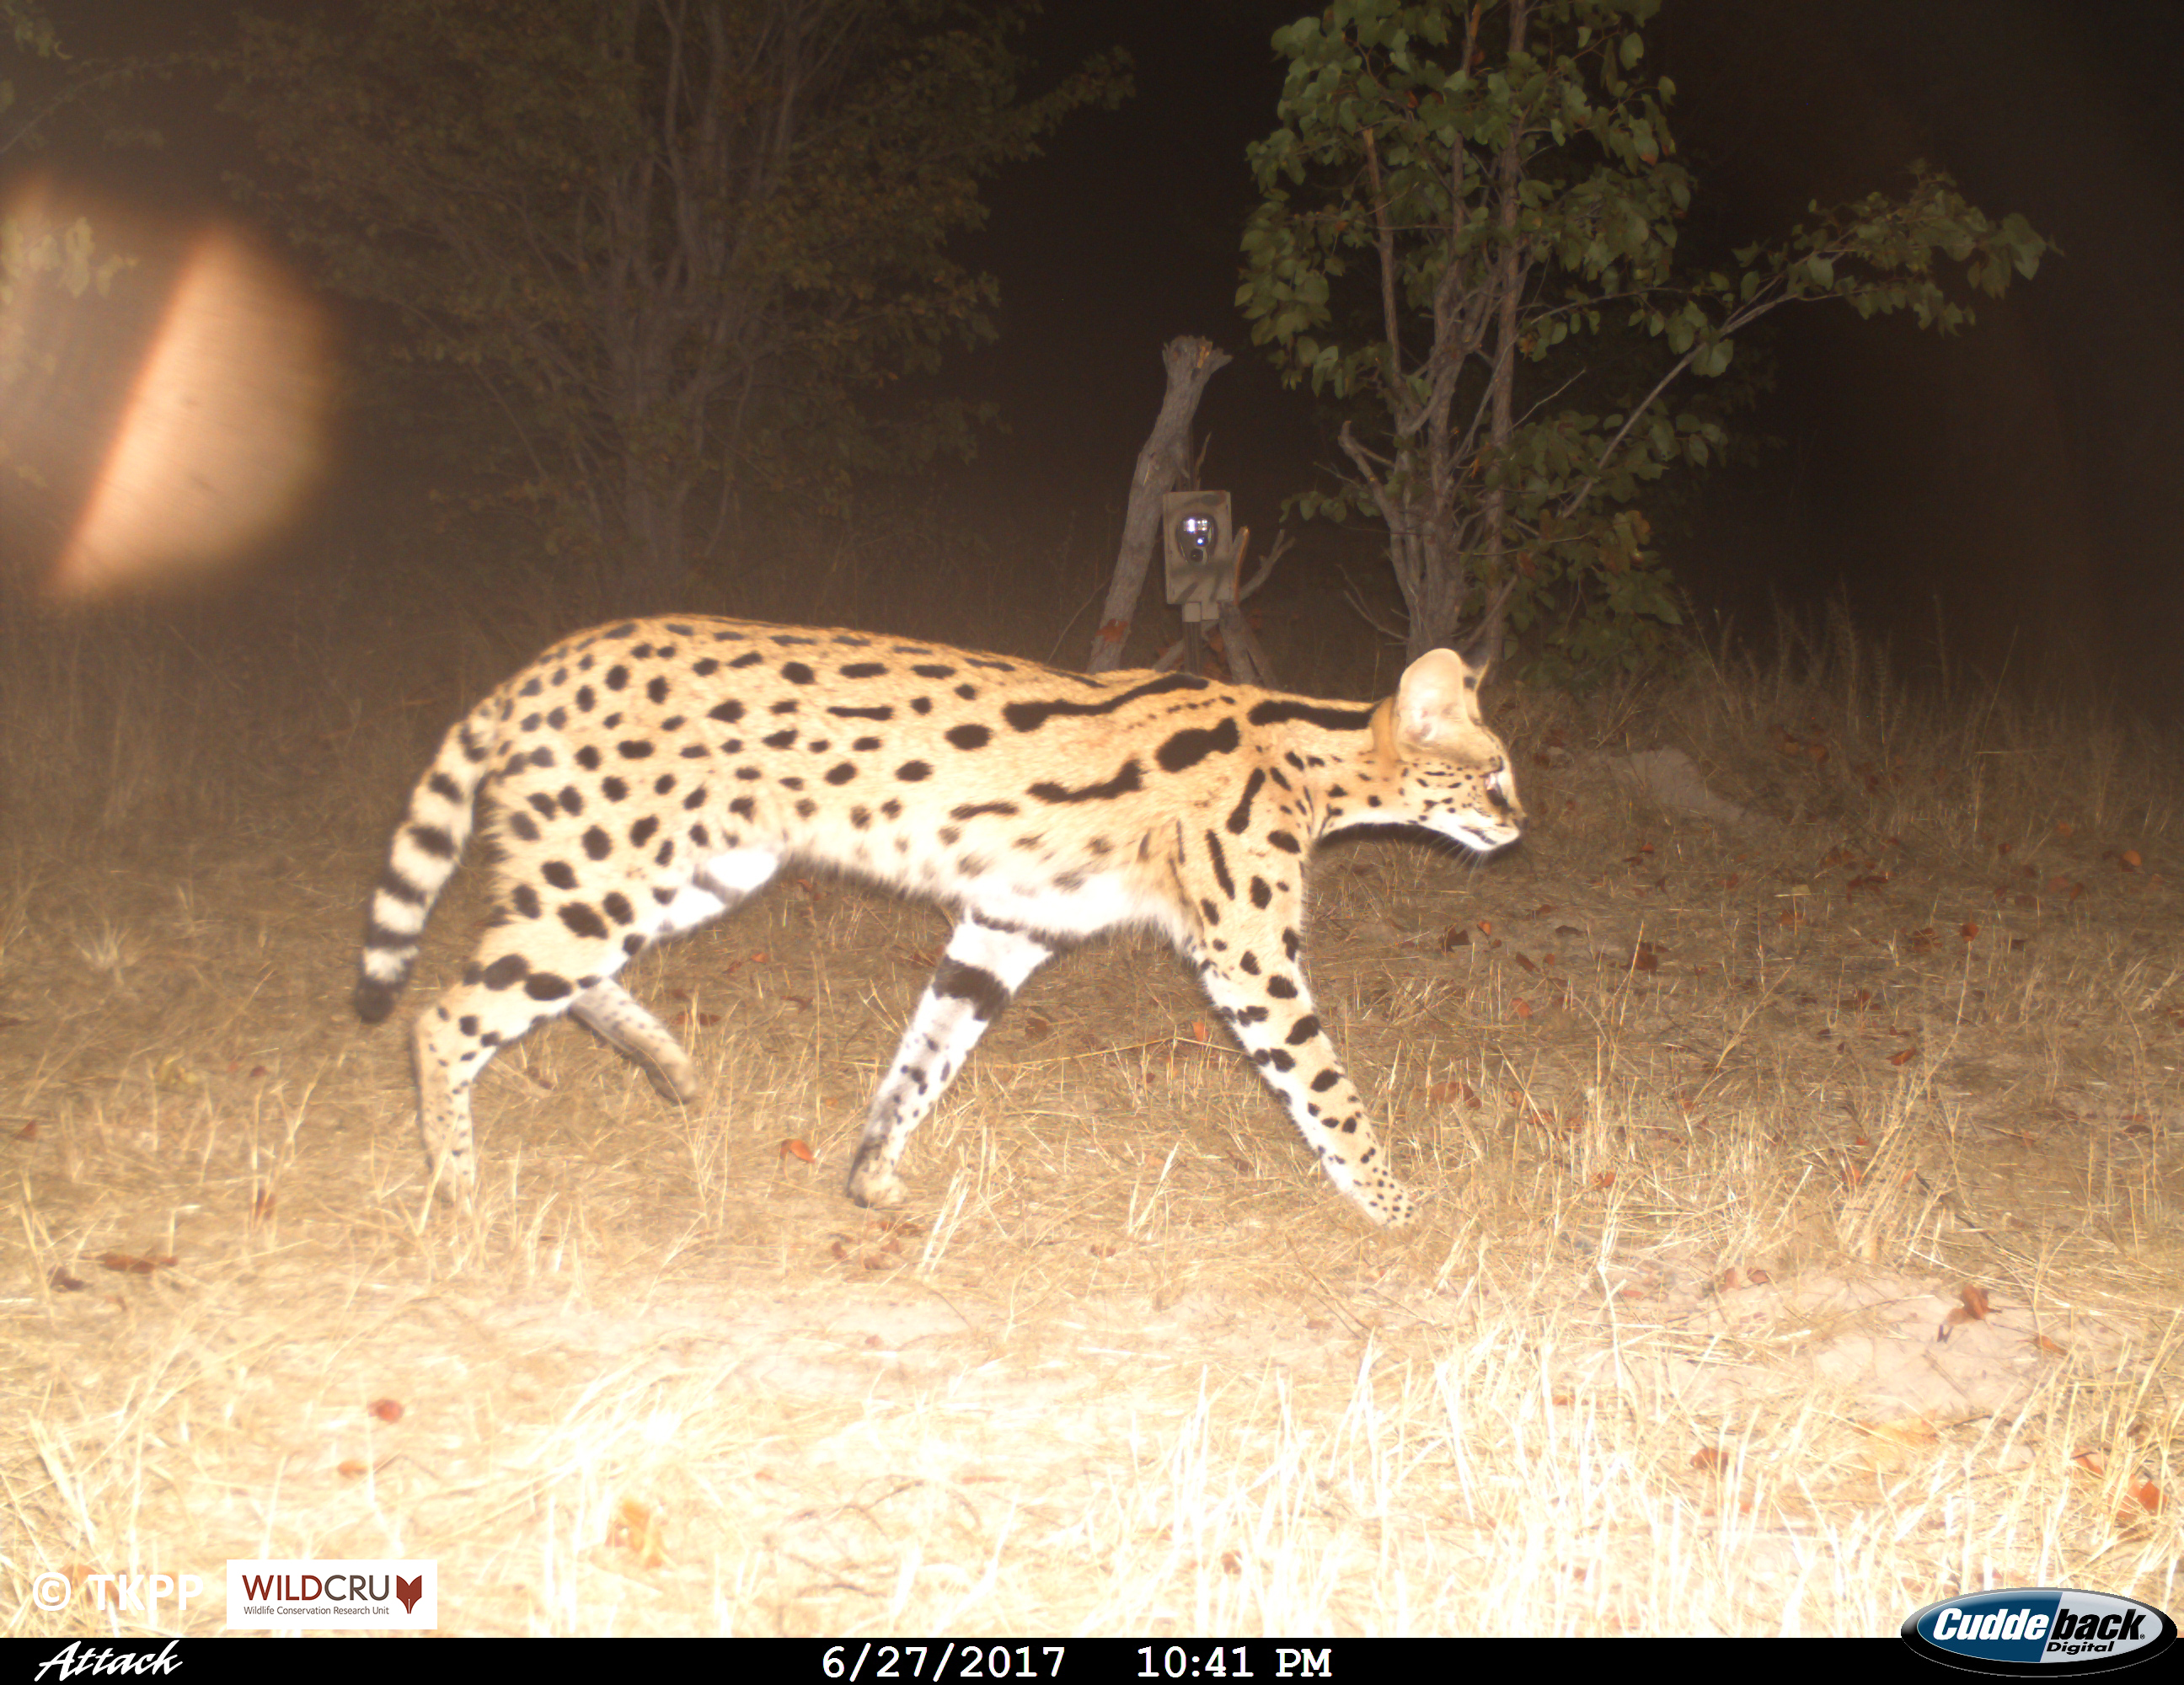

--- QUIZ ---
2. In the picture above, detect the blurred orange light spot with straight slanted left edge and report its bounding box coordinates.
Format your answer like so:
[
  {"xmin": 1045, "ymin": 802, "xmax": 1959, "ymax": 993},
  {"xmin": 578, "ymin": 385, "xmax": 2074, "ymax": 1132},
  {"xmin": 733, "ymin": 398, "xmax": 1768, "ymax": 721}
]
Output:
[{"xmin": 48, "ymin": 233, "xmax": 328, "ymax": 598}]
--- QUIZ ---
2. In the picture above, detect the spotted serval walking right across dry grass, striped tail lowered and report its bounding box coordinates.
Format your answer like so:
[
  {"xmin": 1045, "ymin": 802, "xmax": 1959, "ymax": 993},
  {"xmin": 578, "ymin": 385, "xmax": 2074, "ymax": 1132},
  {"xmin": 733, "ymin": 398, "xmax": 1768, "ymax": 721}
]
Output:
[{"xmin": 356, "ymin": 618, "xmax": 1524, "ymax": 1222}]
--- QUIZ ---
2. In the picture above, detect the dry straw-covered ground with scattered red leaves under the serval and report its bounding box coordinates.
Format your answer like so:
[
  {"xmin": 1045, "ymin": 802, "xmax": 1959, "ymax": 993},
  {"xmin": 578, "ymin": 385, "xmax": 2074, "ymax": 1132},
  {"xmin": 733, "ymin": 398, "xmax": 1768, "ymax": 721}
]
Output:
[{"xmin": 0, "ymin": 671, "xmax": 2184, "ymax": 1637}]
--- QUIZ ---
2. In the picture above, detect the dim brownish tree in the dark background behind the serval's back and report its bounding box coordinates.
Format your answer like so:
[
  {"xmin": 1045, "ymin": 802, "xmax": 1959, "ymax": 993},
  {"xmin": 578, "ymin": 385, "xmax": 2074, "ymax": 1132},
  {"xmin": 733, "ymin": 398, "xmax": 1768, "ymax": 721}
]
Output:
[{"xmin": 228, "ymin": 0, "xmax": 1127, "ymax": 609}]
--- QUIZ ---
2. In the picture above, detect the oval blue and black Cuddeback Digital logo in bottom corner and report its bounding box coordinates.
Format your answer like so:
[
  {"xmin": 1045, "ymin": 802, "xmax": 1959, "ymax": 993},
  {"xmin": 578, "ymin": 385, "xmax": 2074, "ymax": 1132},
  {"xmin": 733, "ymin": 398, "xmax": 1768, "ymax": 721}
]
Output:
[{"xmin": 1900, "ymin": 1586, "xmax": 2177, "ymax": 1674}]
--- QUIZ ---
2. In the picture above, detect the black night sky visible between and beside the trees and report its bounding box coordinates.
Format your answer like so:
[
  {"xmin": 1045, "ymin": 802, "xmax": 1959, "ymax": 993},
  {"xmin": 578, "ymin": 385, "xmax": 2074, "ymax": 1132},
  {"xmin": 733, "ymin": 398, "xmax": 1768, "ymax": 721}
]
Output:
[{"xmin": 29, "ymin": 0, "xmax": 2184, "ymax": 714}]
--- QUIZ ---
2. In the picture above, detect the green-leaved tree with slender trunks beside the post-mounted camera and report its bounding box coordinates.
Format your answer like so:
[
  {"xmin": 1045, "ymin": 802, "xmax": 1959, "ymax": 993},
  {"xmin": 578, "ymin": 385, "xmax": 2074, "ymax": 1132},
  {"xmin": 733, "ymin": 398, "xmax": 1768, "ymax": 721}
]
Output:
[{"xmin": 1236, "ymin": 0, "xmax": 2044, "ymax": 659}]
